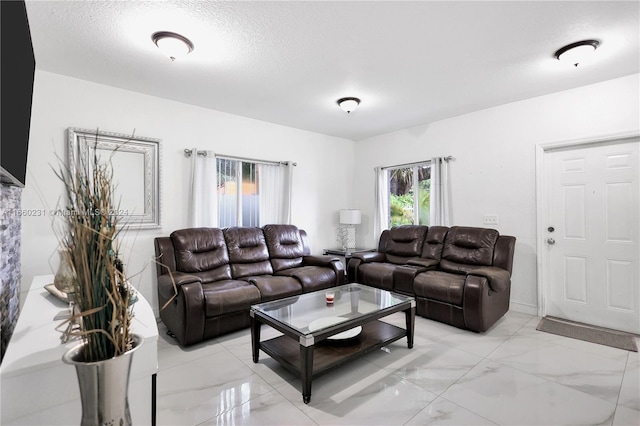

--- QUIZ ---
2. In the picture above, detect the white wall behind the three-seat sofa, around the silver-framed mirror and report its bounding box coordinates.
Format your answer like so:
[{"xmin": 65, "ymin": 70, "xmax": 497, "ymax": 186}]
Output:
[{"xmin": 22, "ymin": 71, "xmax": 354, "ymax": 312}]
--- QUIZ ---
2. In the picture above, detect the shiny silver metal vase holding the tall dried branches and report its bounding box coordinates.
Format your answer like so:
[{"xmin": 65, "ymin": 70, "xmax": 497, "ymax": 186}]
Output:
[{"xmin": 62, "ymin": 334, "xmax": 144, "ymax": 426}]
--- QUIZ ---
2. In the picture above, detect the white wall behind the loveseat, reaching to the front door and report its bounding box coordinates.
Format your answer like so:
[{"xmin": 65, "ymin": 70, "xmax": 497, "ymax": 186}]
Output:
[{"xmin": 354, "ymin": 74, "xmax": 640, "ymax": 313}]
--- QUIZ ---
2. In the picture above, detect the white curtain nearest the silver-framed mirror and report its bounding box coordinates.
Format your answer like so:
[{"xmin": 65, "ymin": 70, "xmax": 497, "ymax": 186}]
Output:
[{"xmin": 189, "ymin": 148, "xmax": 218, "ymax": 228}]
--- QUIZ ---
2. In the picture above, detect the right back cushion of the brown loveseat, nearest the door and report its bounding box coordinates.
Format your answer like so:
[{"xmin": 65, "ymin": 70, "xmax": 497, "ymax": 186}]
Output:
[{"xmin": 440, "ymin": 226, "xmax": 499, "ymax": 273}]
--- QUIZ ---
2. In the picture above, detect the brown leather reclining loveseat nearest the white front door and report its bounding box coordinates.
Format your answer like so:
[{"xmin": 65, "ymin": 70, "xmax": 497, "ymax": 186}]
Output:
[{"xmin": 347, "ymin": 225, "xmax": 516, "ymax": 332}]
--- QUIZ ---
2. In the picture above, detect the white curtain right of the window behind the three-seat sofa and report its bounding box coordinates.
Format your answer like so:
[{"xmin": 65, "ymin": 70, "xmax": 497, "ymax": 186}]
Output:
[{"xmin": 257, "ymin": 162, "xmax": 293, "ymax": 226}]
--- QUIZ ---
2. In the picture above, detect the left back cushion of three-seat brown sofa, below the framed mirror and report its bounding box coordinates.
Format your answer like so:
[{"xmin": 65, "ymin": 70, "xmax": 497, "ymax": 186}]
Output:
[{"xmin": 170, "ymin": 228, "xmax": 231, "ymax": 281}]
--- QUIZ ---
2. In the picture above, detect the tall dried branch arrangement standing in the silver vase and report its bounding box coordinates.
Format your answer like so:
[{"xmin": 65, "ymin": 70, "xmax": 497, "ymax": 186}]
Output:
[{"xmin": 56, "ymin": 135, "xmax": 133, "ymax": 362}]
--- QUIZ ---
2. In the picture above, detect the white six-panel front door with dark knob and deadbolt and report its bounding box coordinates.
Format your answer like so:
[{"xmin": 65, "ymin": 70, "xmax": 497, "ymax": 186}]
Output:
[{"xmin": 543, "ymin": 138, "xmax": 640, "ymax": 333}]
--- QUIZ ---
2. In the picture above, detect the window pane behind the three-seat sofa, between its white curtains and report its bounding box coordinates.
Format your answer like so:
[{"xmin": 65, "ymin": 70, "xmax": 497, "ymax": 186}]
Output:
[{"xmin": 216, "ymin": 158, "xmax": 260, "ymax": 228}]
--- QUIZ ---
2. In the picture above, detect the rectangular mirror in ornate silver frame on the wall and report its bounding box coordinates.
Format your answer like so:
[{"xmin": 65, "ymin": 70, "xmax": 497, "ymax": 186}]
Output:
[{"xmin": 67, "ymin": 127, "xmax": 161, "ymax": 229}]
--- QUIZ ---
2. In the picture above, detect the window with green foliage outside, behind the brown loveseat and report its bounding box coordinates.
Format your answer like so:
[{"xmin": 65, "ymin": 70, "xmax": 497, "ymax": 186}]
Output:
[{"xmin": 386, "ymin": 161, "xmax": 431, "ymax": 227}]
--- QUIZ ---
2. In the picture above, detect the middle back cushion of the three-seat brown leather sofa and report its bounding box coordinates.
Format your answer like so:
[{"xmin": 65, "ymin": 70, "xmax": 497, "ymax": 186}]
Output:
[{"xmin": 224, "ymin": 227, "xmax": 273, "ymax": 278}]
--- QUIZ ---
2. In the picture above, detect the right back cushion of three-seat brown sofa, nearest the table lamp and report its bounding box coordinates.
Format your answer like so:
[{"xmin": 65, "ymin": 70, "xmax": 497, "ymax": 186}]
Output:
[{"xmin": 262, "ymin": 225, "xmax": 304, "ymax": 272}]
